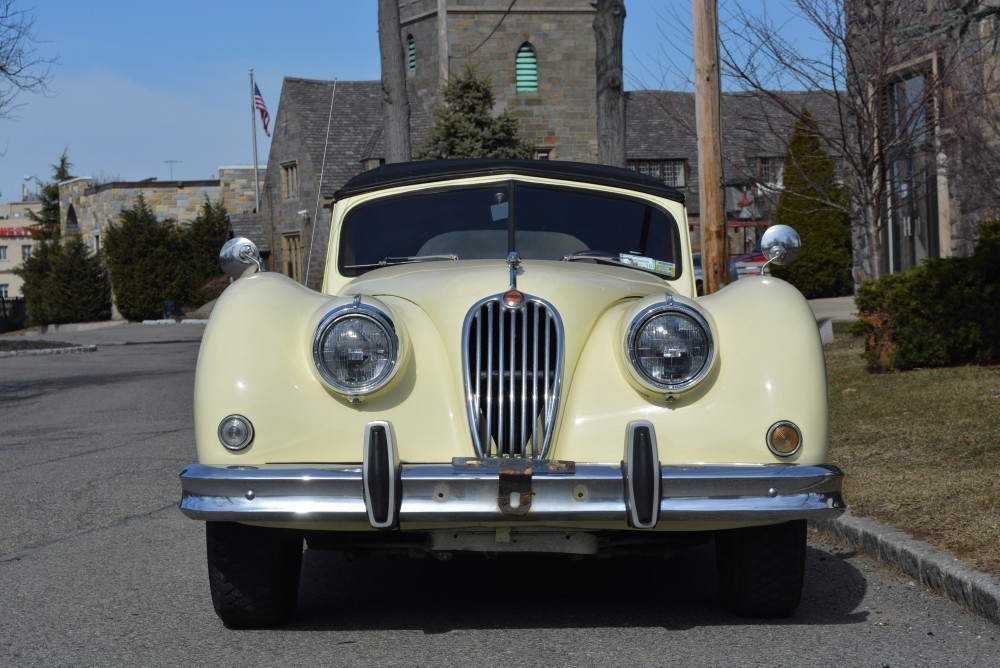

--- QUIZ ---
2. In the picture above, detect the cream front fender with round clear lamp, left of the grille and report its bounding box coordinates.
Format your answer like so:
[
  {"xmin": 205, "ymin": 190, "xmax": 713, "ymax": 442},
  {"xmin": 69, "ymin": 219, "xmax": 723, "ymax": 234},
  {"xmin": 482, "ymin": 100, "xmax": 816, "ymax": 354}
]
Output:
[{"xmin": 194, "ymin": 273, "xmax": 469, "ymax": 466}]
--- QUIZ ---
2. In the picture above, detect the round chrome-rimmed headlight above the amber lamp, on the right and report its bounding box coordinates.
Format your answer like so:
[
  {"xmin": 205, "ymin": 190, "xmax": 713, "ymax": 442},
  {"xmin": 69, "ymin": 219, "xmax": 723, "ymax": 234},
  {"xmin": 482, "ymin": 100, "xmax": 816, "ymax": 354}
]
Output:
[{"xmin": 626, "ymin": 300, "xmax": 715, "ymax": 392}]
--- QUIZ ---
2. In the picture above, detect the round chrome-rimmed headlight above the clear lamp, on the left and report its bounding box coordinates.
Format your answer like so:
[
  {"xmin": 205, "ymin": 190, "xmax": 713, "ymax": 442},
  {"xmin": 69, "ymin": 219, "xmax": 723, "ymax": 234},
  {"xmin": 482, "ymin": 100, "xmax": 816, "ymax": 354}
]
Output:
[{"xmin": 313, "ymin": 303, "xmax": 399, "ymax": 396}]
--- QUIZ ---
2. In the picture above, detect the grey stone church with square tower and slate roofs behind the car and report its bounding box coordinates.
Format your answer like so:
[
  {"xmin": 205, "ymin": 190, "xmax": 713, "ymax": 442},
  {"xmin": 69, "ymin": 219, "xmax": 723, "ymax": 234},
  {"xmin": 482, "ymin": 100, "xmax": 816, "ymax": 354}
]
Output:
[{"xmin": 262, "ymin": 0, "xmax": 833, "ymax": 289}]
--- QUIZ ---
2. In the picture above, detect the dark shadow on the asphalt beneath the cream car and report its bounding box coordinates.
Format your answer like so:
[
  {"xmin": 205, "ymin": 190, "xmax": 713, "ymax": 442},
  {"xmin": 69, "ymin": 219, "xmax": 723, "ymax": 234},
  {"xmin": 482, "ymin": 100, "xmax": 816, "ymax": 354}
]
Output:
[{"xmin": 288, "ymin": 545, "xmax": 867, "ymax": 634}]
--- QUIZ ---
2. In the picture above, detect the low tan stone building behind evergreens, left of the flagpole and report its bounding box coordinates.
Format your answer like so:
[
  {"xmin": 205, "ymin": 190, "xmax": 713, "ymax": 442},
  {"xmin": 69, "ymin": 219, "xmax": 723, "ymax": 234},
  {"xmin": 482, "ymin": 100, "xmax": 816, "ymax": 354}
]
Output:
[{"xmin": 59, "ymin": 167, "xmax": 263, "ymax": 252}]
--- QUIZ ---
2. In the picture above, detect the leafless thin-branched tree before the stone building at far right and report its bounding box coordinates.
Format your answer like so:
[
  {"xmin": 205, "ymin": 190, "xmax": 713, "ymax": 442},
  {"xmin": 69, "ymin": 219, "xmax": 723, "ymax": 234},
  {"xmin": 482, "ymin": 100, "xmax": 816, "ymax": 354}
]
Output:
[{"xmin": 652, "ymin": 0, "xmax": 1000, "ymax": 283}]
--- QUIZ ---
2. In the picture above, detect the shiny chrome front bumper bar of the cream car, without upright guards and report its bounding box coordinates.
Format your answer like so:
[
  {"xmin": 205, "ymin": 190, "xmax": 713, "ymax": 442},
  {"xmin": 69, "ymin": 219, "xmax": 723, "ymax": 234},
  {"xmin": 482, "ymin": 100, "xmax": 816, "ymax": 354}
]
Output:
[{"xmin": 180, "ymin": 464, "xmax": 846, "ymax": 529}]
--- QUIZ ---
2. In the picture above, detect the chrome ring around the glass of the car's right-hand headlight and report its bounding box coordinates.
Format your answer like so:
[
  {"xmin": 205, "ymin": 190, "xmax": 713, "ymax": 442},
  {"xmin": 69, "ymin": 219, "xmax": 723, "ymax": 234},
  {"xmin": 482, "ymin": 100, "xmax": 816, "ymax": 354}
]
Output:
[{"xmin": 625, "ymin": 297, "xmax": 716, "ymax": 395}]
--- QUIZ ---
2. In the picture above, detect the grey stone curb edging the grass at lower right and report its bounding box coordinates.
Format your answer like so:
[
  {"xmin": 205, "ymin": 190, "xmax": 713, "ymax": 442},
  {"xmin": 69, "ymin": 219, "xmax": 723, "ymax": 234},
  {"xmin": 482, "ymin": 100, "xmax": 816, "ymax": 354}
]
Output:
[{"xmin": 811, "ymin": 511, "xmax": 1000, "ymax": 624}]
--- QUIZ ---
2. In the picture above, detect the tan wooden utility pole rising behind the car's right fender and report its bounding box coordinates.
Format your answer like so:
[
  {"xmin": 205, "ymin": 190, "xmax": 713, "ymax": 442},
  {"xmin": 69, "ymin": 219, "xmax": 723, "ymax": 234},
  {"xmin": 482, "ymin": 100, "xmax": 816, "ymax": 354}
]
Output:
[{"xmin": 691, "ymin": 0, "xmax": 729, "ymax": 295}]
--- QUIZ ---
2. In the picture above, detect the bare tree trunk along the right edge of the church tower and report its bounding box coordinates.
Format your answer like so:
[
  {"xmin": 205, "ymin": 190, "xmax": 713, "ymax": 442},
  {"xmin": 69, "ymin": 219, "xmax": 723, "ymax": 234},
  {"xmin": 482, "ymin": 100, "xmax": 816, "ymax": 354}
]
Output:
[{"xmin": 594, "ymin": 0, "xmax": 625, "ymax": 167}]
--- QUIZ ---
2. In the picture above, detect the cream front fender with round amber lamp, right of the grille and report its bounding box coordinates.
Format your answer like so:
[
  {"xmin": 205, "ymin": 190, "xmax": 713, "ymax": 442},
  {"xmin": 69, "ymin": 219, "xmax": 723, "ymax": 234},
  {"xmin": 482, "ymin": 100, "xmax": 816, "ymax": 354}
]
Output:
[{"xmin": 555, "ymin": 276, "xmax": 827, "ymax": 464}]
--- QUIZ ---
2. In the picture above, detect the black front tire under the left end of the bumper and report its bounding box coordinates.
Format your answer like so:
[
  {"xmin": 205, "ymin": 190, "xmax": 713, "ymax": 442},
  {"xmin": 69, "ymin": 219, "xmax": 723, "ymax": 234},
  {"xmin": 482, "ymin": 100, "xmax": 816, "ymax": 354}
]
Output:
[{"xmin": 205, "ymin": 522, "xmax": 302, "ymax": 629}]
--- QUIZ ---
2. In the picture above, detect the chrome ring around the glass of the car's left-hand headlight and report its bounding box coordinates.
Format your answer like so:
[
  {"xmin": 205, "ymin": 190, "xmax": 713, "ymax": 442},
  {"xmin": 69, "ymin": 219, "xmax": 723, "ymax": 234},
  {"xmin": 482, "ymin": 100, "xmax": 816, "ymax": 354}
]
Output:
[{"xmin": 312, "ymin": 299, "xmax": 400, "ymax": 399}]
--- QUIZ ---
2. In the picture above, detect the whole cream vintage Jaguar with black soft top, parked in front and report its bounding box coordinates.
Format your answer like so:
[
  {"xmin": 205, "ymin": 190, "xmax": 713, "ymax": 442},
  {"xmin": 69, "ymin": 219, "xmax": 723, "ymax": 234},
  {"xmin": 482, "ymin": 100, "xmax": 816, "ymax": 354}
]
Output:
[{"xmin": 180, "ymin": 160, "xmax": 844, "ymax": 627}]
